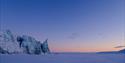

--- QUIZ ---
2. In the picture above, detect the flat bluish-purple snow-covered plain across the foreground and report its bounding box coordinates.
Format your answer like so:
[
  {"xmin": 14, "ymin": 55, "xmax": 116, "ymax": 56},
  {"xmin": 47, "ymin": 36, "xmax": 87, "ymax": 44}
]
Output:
[{"xmin": 0, "ymin": 53, "xmax": 125, "ymax": 63}]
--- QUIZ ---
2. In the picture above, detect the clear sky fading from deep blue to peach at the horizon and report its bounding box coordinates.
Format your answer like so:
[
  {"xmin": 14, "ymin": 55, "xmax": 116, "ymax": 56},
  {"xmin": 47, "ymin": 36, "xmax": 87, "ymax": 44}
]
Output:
[{"xmin": 0, "ymin": 0, "xmax": 125, "ymax": 52}]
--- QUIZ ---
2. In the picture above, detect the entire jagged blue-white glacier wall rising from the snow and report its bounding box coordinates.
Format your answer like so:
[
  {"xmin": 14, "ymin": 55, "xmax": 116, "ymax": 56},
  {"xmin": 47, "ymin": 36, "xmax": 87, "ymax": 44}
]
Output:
[{"xmin": 0, "ymin": 30, "xmax": 50, "ymax": 54}]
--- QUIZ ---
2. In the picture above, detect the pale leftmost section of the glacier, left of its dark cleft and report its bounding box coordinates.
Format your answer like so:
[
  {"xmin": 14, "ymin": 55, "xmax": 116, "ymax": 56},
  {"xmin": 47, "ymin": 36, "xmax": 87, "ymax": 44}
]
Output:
[{"xmin": 0, "ymin": 30, "xmax": 22, "ymax": 53}]
